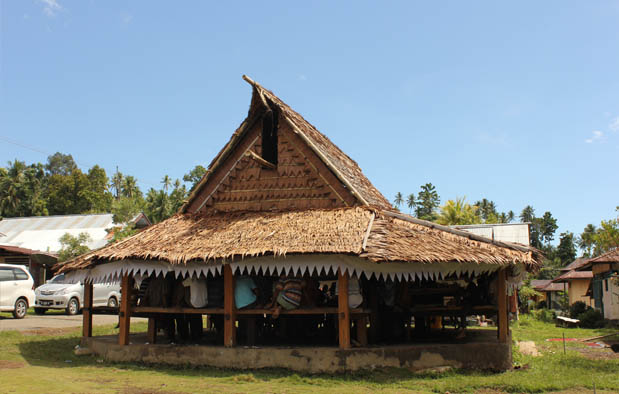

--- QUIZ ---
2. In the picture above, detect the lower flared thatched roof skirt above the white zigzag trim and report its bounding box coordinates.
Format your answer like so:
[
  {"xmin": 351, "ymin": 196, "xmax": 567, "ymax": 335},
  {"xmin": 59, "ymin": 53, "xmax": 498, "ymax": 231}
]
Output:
[{"xmin": 61, "ymin": 207, "xmax": 541, "ymax": 272}]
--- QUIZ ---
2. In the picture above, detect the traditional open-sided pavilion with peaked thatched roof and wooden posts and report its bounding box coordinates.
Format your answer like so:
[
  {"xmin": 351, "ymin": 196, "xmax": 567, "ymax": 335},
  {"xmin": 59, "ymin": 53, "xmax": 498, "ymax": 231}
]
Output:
[{"xmin": 63, "ymin": 77, "xmax": 541, "ymax": 371}]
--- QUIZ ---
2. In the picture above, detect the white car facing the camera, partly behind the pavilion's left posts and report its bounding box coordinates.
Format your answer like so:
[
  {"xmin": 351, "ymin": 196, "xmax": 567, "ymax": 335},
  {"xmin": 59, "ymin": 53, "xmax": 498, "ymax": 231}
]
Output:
[{"xmin": 34, "ymin": 274, "xmax": 120, "ymax": 315}]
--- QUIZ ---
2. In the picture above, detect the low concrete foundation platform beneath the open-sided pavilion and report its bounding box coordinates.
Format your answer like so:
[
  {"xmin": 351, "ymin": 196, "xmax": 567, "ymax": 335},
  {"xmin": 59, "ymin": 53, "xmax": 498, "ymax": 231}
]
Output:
[{"xmin": 82, "ymin": 330, "xmax": 512, "ymax": 373}]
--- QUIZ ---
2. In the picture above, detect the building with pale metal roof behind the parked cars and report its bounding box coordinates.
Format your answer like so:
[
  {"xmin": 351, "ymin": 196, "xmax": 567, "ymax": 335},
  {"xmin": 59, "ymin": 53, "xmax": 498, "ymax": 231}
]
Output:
[{"xmin": 0, "ymin": 213, "xmax": 151, "ymax": 286}]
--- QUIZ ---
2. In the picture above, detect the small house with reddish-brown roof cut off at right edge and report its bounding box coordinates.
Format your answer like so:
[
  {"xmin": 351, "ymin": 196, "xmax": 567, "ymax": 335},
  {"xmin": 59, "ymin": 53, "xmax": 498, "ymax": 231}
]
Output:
[{"xmin": 576, "ymin": 248, "xmax": 619, "ymax": 320}]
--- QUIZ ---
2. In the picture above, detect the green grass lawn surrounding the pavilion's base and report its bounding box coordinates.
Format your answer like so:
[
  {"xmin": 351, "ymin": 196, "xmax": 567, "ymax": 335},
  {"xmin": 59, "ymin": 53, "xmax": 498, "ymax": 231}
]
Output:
[{"xmin": 0, "ymin": 316, "xmax": 619, "ymax": 394}]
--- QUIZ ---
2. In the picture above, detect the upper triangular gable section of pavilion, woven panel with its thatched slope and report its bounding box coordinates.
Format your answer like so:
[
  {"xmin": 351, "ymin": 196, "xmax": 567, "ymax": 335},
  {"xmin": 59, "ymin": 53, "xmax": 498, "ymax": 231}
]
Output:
[{"xmin": 181, "ymin": 82, "xmax": 392, "ymax": 213}]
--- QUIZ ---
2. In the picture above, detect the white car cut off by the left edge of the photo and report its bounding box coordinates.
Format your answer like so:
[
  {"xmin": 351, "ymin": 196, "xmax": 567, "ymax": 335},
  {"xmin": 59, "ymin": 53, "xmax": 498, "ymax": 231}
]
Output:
[{"xmin": 0, "ymin": 264, "xmax": 35, "ymax": 319}]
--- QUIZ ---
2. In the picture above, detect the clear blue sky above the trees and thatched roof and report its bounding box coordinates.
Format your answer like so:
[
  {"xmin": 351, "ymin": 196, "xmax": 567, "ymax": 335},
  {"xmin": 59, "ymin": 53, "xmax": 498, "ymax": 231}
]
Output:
[{"xmin": 0, "ymin": 0, "xmax": 619, "ymax": 243}]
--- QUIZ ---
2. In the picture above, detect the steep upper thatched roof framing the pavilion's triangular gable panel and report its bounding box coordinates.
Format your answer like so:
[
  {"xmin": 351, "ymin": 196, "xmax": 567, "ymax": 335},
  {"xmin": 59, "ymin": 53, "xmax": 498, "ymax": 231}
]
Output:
[{"xmin": 181, "ymin": 76, "xmax": 392, "ymax": 212}]
